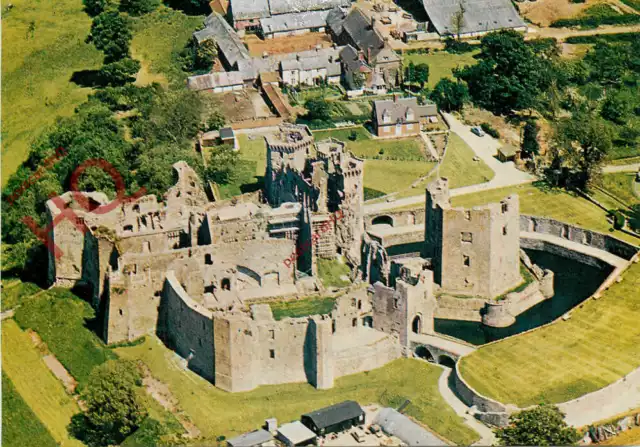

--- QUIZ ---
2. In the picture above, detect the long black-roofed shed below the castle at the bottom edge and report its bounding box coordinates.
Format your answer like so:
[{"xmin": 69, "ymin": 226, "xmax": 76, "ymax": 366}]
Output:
[{"xmin": 300, "ymin": 400, "xmax": 364, "ymax": 436}]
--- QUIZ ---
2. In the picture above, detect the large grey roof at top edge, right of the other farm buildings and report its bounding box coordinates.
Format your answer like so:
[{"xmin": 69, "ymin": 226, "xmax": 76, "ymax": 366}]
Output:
[{"xmin": 422, "ymin": 0, "xmax": 526, "ymax": 35}]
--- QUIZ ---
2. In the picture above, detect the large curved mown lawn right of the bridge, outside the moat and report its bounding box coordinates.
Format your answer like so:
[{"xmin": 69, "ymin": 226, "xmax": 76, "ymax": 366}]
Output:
[{"xmin": 460, "ymin": 264, "xmax": 640, "ymax": 407}]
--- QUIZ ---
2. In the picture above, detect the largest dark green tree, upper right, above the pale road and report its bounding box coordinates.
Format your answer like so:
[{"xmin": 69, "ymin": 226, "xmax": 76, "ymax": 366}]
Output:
[{"xmin": 456, "ymin": 30, "xmax": 551, "ymax": 114}]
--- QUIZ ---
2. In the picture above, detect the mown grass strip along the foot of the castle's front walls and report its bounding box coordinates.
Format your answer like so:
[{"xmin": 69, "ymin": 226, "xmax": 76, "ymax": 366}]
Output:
[{"xmin": 116, "ymin": 337, "xmax": 479, "ymax": 445}]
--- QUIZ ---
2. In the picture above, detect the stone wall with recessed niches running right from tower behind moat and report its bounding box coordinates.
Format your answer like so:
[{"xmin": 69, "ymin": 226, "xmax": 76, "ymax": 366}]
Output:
[{"xmin": 520, "ymin": 214, "xmax": 638, "ymax": 261}]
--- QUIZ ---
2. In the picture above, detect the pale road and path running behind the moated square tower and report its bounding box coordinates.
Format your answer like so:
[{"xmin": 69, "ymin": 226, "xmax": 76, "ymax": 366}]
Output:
[{"xmin": 364, "ymin": 113, "xmax": 536, "ymax": 214}]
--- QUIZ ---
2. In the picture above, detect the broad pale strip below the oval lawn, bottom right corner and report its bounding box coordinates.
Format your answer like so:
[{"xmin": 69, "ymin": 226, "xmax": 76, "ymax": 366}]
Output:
[{"xmin": 558, "ymin": 368, "xmax": 640, "ymax": 427}]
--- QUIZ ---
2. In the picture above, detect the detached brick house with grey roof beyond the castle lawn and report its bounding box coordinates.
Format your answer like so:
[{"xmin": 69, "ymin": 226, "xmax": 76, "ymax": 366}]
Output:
[{"xmin": 373, "ymin": 96, "xmax": 438, "ymax": 138}]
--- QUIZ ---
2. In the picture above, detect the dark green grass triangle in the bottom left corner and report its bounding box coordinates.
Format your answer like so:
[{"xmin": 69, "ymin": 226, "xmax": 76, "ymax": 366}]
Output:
[{"xmin": 2, "ymin": 371, "xmax": 58, "ymax": 447}]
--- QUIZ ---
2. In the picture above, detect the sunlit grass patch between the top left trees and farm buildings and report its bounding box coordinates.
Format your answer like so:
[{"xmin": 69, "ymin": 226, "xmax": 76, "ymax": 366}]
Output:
[{"xmin": 131, "ymin": 6, "xmax": 204, "ymax": 85}]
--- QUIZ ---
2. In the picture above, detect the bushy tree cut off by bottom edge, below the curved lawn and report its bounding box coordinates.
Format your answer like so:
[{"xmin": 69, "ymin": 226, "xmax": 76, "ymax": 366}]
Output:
[{"xmin": 496, "ymin": 405, "xmax": 579, "ymax": 446}]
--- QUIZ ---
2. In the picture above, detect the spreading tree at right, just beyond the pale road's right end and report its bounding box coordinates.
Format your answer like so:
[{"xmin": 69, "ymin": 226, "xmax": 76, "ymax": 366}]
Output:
[{"xmin": 553, "ymin": 112, "xmax": 614, "ymax": 188}]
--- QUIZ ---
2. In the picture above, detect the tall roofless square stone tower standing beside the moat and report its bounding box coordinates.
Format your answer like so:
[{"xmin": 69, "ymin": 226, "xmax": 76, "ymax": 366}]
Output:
[{"xmin": 424, "ymin": 178, "xmax": 522, "ymax": 298}]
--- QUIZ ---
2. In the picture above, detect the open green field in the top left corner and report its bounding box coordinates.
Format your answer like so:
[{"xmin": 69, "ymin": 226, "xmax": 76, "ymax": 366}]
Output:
[{"xmin": 2, "ymin": 0, "xmax": 102, "ymax": 185}]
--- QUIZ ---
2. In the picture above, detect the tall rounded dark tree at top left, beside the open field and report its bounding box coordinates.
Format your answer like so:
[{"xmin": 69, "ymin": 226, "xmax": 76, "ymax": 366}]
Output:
[{"xmin": 89, "ymin": 11, "xmax": 132, "ymax": 62}]
